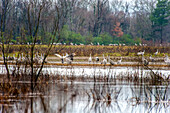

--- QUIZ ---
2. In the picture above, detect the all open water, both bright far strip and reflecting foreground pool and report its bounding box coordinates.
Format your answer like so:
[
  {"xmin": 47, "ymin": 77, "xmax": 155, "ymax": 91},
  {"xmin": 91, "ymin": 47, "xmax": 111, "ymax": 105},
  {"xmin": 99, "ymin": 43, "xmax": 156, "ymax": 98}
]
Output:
[{"xmin": 0, "ymin": 65, "xmax": 170, "ymax": 113}]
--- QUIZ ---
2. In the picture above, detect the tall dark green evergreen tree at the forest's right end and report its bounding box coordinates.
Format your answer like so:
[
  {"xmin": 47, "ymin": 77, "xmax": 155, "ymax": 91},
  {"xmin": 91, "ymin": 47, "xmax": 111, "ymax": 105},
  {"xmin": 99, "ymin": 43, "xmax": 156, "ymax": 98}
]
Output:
[{"xmin": 150, "ymin": 0, "xmax": 170, "ymax": 43}]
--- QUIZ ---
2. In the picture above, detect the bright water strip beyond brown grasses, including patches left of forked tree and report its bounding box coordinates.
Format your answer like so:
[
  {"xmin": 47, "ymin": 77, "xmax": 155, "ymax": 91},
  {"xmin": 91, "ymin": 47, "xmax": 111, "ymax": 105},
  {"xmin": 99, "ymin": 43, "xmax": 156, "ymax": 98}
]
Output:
[{"xmin": 0, "ymin": 65, "xmax": 170, "ymax": 76}]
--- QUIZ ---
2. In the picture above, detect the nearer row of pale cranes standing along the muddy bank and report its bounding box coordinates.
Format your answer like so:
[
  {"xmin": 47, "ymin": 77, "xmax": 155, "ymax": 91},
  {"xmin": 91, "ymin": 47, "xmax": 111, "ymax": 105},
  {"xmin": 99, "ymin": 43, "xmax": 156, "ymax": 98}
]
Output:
[{"xmin": 2, "ymin": 49, "xmax": 170, "ymax": 66}]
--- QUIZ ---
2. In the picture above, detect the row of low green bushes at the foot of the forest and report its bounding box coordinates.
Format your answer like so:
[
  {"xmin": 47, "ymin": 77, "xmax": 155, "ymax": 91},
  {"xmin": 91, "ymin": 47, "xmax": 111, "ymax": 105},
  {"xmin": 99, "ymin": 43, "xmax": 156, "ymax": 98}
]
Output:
[{"xmin": 60, "ymin": 26, "xmax": 141, "ymax": 45}]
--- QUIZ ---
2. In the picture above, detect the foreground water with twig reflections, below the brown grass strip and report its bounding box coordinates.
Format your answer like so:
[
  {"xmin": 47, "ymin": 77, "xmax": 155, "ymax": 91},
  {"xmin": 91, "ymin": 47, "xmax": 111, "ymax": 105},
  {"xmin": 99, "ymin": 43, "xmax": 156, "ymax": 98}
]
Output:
[{"xmin": 0, "ymin": 81, "xmax": 170, "ymax": 113}]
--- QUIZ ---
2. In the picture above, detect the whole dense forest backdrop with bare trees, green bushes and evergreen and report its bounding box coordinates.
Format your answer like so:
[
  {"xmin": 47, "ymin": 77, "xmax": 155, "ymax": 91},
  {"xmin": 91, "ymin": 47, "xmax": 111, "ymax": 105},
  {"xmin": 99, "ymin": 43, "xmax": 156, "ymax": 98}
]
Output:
[{"xmin": 0, "ymin": 0, "xmax": 170, "ymax": 45}]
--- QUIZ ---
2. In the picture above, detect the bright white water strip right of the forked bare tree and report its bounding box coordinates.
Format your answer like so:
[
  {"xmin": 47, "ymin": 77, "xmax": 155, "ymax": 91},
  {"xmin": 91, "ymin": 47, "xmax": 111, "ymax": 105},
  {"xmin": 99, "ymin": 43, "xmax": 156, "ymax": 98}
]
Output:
[{"xmin": 43, "ymin": 66, "xmax": 170, "ymax": 77}]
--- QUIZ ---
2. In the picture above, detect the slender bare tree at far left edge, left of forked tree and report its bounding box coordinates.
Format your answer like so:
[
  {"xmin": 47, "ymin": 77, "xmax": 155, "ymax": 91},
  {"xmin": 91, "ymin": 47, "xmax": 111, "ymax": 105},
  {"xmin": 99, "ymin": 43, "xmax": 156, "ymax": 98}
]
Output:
[{"xmin": 0, "ymin": 0, "xmax": 12, "ymax": 81}]
